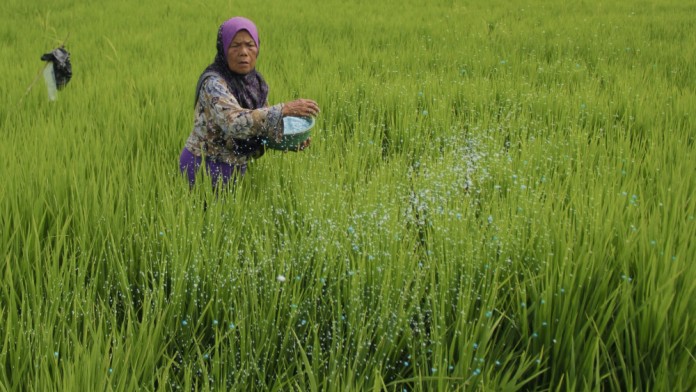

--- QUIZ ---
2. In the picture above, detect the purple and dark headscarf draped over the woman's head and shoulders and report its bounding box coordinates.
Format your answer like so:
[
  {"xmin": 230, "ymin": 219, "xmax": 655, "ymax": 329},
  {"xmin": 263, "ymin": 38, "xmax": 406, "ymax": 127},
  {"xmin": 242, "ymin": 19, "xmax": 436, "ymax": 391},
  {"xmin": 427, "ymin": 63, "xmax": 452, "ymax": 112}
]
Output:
[{"xmin": 194, "ymin": 16, "xmax": 268, "ymax": 109}]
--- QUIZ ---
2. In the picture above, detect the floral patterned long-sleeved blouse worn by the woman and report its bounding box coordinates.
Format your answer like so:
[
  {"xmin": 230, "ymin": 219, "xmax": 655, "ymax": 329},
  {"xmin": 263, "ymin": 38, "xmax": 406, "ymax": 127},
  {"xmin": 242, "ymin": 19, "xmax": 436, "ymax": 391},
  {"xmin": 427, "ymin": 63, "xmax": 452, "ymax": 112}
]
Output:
[{"xmin": 186, "ymin": 75, "xmax": 283, "ymax": 165}]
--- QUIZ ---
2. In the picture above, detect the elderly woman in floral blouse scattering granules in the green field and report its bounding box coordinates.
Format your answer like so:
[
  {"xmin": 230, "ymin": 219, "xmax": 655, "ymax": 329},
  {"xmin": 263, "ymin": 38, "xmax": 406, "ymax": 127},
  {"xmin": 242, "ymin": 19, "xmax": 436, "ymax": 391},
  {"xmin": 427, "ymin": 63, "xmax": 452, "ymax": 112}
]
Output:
[{"xmin": 179, "ymin": 17, "xmax": 319, "ymax": 186}]
